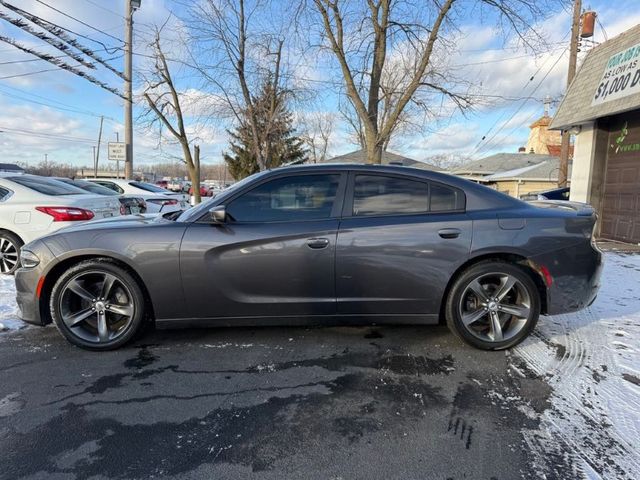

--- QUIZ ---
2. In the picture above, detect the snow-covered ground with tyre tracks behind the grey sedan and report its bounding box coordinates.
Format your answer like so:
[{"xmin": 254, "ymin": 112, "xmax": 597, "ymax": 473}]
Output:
[{"xmin": 514, "ymin": 253, "xmax": 640, "ymax": 478}]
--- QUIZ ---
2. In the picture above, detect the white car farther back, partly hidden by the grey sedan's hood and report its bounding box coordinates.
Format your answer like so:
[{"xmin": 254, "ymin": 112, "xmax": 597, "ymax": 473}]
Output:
[{"xmin": 85, "ymin": 178, "xmax": 189, "ymax": 213}]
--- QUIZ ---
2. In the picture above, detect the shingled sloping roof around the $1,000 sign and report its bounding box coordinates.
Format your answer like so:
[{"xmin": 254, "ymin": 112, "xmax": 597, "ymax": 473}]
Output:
[{"xmin": 549, "ymin": 25, "xmax": 640, "ymax": 130}]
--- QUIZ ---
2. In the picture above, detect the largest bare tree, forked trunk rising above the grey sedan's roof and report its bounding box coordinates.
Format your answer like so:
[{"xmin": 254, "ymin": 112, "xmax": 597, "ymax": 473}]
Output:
[{"xmin": 313, "ymin": 0, "xmax": 553, "ymax": 163}]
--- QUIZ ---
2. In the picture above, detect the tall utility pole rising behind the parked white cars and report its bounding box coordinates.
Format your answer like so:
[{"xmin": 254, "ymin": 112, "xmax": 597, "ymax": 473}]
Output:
[{"xmin": 124, "ymin": 0, "xmax": 140, "ymax": 179}]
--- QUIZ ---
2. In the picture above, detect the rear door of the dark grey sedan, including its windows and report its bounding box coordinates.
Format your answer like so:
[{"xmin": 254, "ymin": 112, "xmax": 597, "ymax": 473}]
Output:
[{"xmin": 336, "ymin": 172, "xmax": 472, "ymax": 315}]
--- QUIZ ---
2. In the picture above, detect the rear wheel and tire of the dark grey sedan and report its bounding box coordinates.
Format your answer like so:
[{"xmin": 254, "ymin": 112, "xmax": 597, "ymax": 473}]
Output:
[{"xmin": 445, "ymin": 260, "xmax": 540, "ymax": 350}]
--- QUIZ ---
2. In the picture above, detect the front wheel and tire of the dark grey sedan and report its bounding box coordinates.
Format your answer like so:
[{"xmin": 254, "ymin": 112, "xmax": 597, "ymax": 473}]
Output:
[{"xmin": 49, "ymin": 259, "xmax": 146, "ymax": 351}]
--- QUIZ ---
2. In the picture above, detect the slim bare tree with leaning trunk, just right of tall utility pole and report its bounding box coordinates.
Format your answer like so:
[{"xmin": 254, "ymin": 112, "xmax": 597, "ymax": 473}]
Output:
[{"xmin": 143, "ymin": 29, "xmax": 200, "ymax": 203}]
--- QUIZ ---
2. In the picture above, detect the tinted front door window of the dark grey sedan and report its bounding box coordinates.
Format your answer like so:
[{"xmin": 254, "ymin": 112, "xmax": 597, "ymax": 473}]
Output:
[{"xmin": 227, "ymin": 175, "xmax": 340, "ymax": 222}]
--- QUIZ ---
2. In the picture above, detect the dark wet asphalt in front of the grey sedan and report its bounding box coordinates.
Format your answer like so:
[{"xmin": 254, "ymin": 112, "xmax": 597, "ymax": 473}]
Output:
[{"xmin": 0, "ymin": 326, "xmax": 573, "ymax": 480}]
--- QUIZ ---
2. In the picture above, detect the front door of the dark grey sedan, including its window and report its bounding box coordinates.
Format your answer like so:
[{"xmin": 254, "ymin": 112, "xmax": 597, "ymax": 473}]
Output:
[{"xmin": 180, "ymin": 173, "xmax": 346, "ymax": 318}]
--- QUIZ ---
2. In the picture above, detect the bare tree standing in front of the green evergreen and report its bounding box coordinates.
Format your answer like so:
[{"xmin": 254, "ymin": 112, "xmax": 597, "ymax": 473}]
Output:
[{"xmin": 190, "ymin": 0, "xmax": 300, "ymax": 170}]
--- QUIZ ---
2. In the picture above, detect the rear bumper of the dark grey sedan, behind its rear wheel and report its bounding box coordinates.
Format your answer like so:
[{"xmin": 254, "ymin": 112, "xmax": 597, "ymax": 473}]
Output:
[{"xmin": 532, "ymin": 242, "xmax": 604, "ymax": 315}]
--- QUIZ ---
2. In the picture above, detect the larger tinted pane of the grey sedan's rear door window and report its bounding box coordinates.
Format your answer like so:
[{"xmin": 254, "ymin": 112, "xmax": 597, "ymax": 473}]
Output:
[{"xmin": 353, "ymin": 175, "xmax": 429, "ymax": 215}]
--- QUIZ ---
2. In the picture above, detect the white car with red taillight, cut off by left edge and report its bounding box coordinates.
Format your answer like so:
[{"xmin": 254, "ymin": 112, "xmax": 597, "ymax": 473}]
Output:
[{"xmin": 0, "ymin": 173, "xmax": 120, "ymax": 274}]
